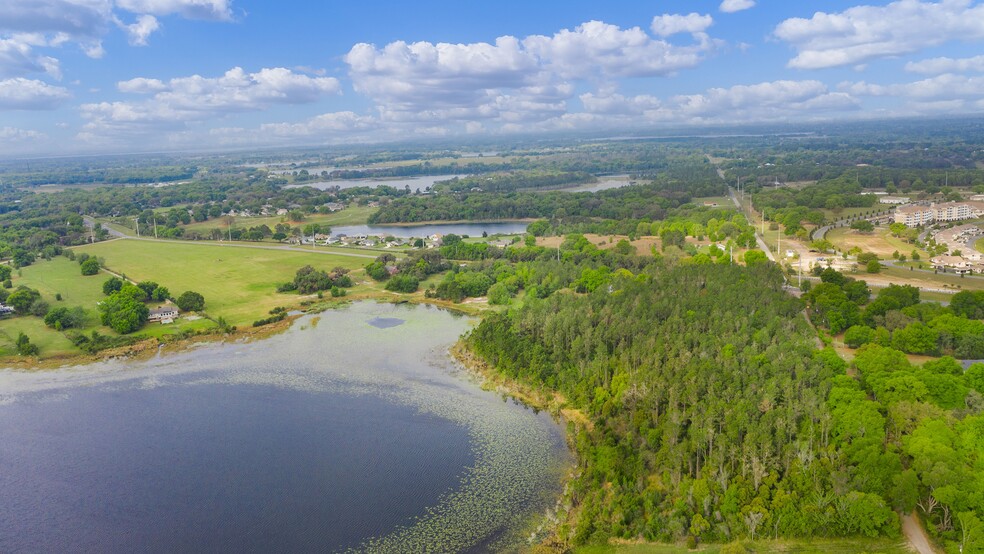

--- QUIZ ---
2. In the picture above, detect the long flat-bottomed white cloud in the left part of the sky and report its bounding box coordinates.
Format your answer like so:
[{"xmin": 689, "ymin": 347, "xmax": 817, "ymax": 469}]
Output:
[{"xmin": 81, "ymin": 67, "xmax": 340, "ymax": 138}]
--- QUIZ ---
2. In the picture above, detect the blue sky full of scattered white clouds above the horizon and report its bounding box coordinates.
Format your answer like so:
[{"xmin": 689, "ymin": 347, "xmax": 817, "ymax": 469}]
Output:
[{"xmin": 0, "ymin": 0, "xmax": 984, "ymax": 157}]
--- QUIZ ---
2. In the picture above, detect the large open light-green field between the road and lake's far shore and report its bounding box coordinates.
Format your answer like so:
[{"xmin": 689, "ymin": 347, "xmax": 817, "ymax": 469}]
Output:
[{"xmin": 75, "ymin": 239, "xmax": 372, "ymax": 326}]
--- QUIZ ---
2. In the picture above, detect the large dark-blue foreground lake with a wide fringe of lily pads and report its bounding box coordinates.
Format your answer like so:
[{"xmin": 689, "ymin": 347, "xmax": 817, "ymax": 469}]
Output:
[{"xmin": 0, "ymin": 302, "xmax": 571, "ymax": 552}]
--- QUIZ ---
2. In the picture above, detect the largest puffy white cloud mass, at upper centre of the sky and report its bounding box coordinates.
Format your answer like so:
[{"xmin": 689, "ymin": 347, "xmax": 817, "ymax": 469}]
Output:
[{"xmin": 344, "ymin": 18, "xmax": 719, "ymax": 122}]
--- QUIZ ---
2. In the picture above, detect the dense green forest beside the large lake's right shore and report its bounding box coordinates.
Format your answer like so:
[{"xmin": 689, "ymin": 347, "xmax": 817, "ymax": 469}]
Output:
[{"xmin": 465, "ymin": 261, "xmax": 984, "ymax": 551}]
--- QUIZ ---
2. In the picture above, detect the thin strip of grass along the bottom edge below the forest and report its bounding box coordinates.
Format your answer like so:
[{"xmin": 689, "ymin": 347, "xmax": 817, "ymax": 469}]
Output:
[{"xmin": 574, "ymin": 539, "xmax": 912, "ymax": 554}]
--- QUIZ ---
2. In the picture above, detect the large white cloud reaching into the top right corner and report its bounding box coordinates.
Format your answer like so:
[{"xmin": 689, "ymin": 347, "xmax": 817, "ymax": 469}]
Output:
[{"xmin": 774, "ymin": 0, "xmax": 984, "ymax": 69}]
